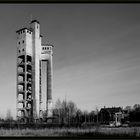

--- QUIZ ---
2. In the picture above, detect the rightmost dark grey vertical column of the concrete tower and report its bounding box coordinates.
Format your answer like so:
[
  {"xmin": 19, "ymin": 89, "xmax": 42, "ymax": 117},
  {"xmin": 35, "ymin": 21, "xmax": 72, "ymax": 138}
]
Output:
[{"xmin": 47, "ymin": 55, "xmax": 52, "ymax": 117}]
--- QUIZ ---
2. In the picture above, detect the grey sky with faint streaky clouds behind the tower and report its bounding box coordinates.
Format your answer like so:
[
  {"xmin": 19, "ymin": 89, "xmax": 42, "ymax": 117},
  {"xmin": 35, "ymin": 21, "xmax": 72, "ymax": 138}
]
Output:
[{"xmin": 0, "ymin": 4, "xmax": 140, "ymax": 117}]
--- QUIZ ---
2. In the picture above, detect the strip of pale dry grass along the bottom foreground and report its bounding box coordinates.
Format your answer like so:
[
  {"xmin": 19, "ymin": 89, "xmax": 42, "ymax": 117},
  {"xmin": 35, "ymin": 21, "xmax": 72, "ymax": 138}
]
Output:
[{"xmin": 0, "ymin": 127, "xmax": 140, "ymax": 137}]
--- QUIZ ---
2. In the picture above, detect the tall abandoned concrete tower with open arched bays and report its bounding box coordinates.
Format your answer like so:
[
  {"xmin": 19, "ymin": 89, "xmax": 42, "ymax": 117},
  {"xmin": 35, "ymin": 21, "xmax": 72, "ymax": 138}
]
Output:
[{"xmin": 16, "ymin": 20, "xmax": 53, "ymax": 122}]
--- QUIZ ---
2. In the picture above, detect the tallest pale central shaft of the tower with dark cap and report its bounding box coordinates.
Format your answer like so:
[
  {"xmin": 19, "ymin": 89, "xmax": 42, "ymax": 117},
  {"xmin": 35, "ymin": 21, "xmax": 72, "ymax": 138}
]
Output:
[{"xmin": 31, "ymin": 20, "xmax": 41, "ymax": 120}]
